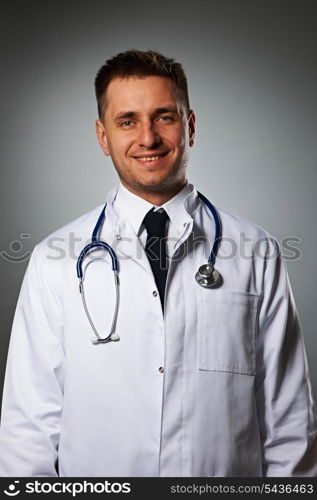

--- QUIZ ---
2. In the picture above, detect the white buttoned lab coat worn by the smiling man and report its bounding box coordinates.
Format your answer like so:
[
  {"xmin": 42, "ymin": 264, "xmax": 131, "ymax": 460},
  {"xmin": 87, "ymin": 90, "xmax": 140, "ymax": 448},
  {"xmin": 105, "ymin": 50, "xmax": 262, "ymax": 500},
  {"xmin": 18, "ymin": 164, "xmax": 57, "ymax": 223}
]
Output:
[{"xmin": 0, "ymin": 185, "xmax": 317, "ymax": 477}]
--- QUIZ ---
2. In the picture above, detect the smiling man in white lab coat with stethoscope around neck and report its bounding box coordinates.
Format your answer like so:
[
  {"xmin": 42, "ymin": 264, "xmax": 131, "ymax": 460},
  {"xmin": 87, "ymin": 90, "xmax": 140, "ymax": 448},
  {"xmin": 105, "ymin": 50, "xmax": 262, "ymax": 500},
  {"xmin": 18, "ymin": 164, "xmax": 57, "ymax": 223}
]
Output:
[{"xmin": 0, "ymin": 51, "xmax": 317, "ymax": 476}]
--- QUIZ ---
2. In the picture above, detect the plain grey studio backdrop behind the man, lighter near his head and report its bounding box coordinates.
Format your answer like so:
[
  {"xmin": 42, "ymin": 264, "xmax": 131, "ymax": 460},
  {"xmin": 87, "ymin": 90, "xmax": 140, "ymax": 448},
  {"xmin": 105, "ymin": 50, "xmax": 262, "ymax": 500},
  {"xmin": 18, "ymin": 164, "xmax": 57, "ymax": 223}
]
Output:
[{"xmin": 0, "ymin": 0, "xmax": 317, "ymax": 404}]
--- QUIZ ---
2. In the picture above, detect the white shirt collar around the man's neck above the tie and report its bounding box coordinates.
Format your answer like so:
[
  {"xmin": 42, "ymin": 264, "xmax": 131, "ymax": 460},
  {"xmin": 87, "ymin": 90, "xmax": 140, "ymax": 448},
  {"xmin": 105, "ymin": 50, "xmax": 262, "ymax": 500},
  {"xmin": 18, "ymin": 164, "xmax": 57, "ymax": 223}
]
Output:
[{"xmin": 115, "ymin": 183, "xmax": 196, "ymax": 235}]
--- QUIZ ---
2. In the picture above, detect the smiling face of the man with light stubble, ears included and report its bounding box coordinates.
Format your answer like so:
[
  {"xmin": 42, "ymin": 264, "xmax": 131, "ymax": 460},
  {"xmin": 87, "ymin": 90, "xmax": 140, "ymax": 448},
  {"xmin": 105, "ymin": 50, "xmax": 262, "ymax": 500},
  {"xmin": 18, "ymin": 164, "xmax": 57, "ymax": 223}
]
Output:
[{"xmin": 96, "ymin": 76, "xmax": 195, "ymax": 196}]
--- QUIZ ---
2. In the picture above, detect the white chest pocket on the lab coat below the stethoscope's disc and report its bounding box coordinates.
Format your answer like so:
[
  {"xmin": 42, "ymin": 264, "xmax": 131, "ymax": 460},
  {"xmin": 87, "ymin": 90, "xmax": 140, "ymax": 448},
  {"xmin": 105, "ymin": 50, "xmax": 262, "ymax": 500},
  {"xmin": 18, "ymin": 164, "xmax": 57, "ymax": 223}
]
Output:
[{"xmin": 198, "ymin": 289, "xmax": 260, "ymax": 375}]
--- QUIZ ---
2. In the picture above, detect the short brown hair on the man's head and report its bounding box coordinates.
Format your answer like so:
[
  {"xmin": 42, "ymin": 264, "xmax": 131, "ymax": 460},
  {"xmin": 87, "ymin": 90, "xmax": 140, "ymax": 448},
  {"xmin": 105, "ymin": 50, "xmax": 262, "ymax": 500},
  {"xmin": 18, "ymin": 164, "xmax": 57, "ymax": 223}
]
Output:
[{"xmin": 95, "ymin": 49, "xmax": 190, "ymax": 119}]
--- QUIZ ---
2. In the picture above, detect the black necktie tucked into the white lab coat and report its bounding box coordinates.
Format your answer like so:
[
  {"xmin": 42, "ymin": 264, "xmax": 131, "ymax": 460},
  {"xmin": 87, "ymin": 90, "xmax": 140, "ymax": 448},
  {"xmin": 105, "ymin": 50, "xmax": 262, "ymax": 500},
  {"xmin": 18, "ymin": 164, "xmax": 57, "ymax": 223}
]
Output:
[{"xmin": 143, "ymin": 208, "xmax": 168, "ymax": 310}]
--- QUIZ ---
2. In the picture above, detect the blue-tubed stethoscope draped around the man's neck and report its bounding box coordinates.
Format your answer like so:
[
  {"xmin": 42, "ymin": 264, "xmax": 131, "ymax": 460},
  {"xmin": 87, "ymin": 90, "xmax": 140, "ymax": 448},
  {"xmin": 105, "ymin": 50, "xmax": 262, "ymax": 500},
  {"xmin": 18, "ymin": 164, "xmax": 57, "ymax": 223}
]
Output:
[{"xmin": 77, "ymin": 193, "xmax": 222, "ymax": 344}]
